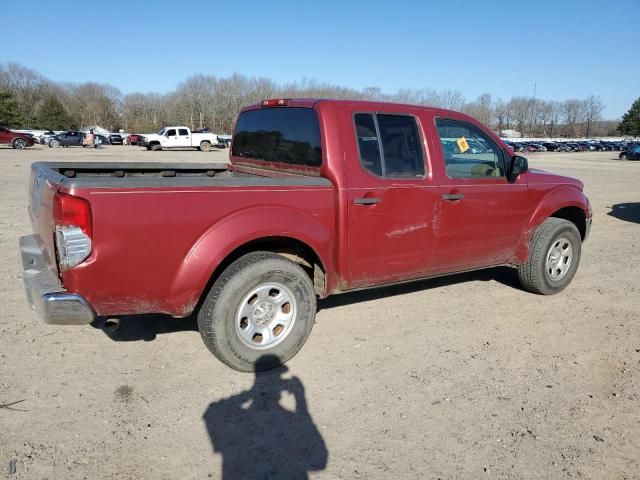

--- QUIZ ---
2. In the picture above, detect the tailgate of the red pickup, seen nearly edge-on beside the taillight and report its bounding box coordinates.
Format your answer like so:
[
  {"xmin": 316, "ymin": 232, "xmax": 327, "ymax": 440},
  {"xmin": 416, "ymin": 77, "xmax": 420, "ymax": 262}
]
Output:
[{"xmin": 29, "ymin": 163, "xmax": 64, "ymax": 274}]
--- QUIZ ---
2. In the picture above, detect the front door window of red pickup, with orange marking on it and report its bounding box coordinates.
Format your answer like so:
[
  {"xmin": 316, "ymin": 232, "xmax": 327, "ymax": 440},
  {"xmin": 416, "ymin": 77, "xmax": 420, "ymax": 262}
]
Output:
[{"xmin": 436, "ymin": 118, "xmax": 505, "ymax": 178}]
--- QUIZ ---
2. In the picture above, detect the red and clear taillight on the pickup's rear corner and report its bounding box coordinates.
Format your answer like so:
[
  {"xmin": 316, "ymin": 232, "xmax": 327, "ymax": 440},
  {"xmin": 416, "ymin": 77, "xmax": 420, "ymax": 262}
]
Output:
[{"xmin": 53, "ymin": 193, "xmax": 93, "ymax": 270}]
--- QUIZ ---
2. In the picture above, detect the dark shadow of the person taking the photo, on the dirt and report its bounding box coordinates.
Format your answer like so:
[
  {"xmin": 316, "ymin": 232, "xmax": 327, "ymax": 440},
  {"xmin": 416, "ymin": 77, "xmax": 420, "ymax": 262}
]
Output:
[{"xmin": 203, "ymin": 355, "xmax": 328, "ymax": 480}]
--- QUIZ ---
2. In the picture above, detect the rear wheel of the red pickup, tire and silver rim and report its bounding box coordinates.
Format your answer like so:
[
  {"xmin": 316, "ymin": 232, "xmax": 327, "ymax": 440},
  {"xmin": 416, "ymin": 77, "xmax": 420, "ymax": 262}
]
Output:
[{"xmin": 198, "ymin": 252, "xmax": 316, "ymax": 372}]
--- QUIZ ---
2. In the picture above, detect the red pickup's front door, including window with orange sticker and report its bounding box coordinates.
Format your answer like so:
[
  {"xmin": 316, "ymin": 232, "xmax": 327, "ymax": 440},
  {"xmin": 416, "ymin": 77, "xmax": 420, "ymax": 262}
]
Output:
[{"xmin": 424, "ymin": 114, "xmax": 531, "ymax": 272}]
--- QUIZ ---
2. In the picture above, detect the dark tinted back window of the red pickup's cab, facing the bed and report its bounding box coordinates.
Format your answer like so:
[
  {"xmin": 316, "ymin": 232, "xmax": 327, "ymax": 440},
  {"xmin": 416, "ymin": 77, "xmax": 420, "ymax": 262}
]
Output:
[{"xmin": 231, "ymin": 107, "xmax": 322, "ymax": 167}]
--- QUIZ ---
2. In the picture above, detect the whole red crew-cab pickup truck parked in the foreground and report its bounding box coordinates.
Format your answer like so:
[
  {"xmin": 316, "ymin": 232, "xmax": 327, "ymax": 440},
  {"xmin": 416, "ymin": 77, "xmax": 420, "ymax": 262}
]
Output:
[{"xmin": 21, "ymin": 99, "xmax": 591, "ymax": 371}]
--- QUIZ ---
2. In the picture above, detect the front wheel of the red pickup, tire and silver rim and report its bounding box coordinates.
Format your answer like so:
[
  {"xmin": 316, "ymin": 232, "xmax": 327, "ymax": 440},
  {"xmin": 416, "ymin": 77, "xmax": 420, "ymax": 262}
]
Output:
[{"xmin": 518, "ymin": 217, "xmax": 582, "ymax": 295}]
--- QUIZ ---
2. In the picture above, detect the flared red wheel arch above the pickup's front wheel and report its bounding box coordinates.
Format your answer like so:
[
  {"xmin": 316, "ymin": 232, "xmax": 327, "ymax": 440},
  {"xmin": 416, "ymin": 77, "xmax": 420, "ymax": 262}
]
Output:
[{"xmin": 516, "ymin": 185, "xmax": 591, "ymax": 263}]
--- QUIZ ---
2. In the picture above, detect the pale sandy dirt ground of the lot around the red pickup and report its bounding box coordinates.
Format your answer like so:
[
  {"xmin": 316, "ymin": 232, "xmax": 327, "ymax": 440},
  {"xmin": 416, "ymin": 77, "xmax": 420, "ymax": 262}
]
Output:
[{"xmin": 0, "ymin": 146, "xmax": 640, "ymax": 480}]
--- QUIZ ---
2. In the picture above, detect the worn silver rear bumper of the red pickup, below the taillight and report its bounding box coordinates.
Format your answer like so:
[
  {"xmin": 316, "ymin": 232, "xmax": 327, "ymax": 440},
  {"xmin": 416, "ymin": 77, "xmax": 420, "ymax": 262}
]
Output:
[{"xmin": 20, "ymin": 235, "xmax": 95, "ymax": 325}]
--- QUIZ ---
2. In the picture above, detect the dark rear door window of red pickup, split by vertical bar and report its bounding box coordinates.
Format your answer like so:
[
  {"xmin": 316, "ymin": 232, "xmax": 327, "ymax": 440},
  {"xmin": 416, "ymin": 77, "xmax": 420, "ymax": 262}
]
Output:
[{"xmin": 354, "ymin": 113, "xmax": 424, "ymax": 177}]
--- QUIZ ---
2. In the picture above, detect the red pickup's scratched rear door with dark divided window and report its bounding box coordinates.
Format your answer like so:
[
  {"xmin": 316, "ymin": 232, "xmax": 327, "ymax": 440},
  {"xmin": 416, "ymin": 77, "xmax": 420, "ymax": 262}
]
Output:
[{"xmin": 339, "ymin": 107, "xmax": 438, "ymax": 287}]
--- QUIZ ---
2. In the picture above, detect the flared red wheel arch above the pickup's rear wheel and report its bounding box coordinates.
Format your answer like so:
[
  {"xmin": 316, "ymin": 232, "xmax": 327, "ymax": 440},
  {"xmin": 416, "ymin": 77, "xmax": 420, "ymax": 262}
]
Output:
[{"xmin": 171, "ymin": 205, "xmax": 334, "ymax": 316}]
